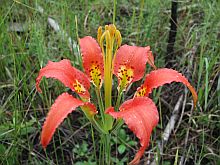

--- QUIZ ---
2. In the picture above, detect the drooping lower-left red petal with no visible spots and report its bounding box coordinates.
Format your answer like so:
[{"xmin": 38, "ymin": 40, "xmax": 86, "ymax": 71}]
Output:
[{"xmin": 41, "ymin": 93, "xmax": 97, "ymax": 148}]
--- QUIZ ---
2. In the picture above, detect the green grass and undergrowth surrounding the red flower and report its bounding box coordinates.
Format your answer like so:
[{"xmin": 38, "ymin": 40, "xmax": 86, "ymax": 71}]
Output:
[{"xmin": 0, "ymin": 0, "xmax": 220, "ymax": 165}]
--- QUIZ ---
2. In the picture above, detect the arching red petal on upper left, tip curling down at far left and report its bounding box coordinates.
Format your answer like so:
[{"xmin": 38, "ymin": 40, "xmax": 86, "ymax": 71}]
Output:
[{"xmin": 36, "ymin": 59, "xmax": 90, "ymax": 98}]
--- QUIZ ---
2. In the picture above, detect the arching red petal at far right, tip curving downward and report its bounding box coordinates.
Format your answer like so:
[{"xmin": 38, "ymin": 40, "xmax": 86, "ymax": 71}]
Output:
[{"xmin": 136, "ymin": 68, "xmax": 197, "ymax": 105}]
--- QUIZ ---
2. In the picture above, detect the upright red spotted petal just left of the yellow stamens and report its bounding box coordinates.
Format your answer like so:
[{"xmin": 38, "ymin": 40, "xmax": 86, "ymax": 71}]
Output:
[{"xmin": 80, "ymin": 36, "xmax": 104, "ymax": 87}]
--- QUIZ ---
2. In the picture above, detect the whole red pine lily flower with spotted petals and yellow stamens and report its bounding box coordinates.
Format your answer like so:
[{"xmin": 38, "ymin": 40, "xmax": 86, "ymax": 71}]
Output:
[{"xmin": 36, "ymin": 25, "xmax": 197, "ymax": 164}]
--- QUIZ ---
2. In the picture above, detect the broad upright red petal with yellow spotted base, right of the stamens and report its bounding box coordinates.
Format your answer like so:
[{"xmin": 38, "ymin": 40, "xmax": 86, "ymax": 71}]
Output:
[{"xmin": 114, "ymin": 45, "xmax": 149, "ymax": 89}]
